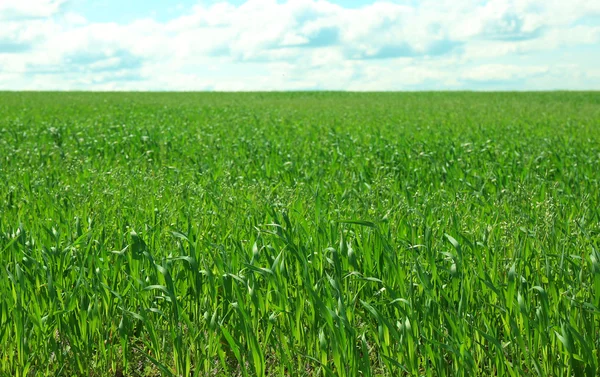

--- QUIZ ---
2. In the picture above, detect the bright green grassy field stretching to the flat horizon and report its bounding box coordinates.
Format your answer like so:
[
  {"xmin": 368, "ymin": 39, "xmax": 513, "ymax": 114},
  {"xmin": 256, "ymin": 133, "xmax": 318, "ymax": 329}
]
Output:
[{"xmin": 0, "ymin": 92, "xmax": 600, "ymax": 377}]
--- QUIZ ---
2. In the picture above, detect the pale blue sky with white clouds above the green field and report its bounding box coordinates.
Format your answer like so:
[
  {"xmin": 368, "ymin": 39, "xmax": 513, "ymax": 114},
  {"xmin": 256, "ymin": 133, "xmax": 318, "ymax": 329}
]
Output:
[{"xmin": 0, "ymin": 0, "xmax": 600, "ymax": 91}]
